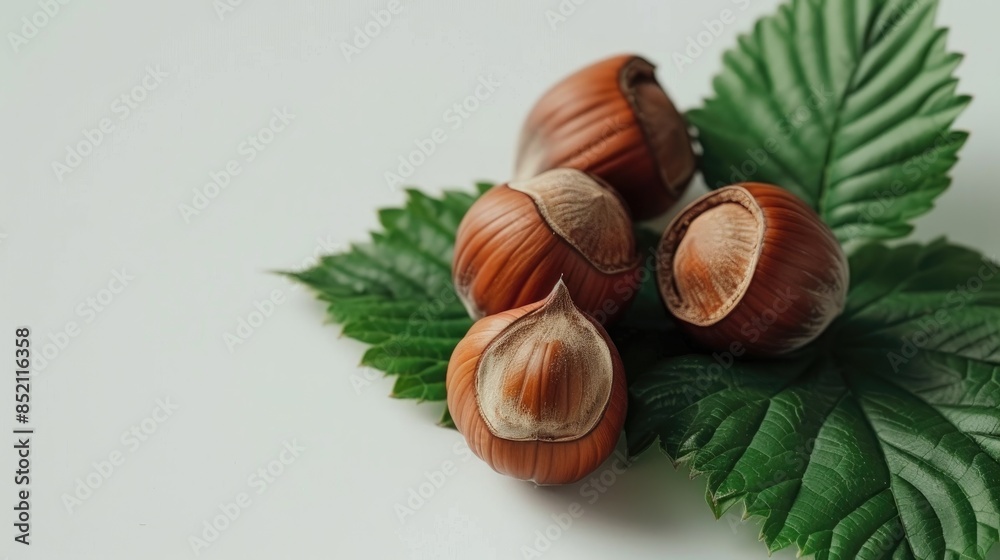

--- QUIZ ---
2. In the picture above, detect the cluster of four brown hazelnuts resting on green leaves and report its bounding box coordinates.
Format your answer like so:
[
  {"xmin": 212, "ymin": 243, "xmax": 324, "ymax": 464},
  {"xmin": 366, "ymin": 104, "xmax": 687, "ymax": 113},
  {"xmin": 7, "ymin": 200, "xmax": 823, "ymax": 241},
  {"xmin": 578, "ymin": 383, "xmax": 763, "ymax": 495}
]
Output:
[{"xmin": 446, "ymin": 55, "xmax": 848, "ymax": 484}]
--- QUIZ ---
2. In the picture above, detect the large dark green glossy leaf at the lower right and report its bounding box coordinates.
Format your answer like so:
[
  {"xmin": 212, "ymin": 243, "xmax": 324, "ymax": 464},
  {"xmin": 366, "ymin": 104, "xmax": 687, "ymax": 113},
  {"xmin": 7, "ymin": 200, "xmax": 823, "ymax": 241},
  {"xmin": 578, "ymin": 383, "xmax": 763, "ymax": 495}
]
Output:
[{"xmin": 626, "ymin": 241, "xmax": 1000, "ymax": 559}]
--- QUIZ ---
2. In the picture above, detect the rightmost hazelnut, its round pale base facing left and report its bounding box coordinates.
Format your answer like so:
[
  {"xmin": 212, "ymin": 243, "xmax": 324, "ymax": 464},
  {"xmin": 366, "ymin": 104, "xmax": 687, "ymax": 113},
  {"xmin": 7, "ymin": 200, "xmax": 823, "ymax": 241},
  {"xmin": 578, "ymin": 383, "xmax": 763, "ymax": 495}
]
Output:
[{"xmin": 657, "ymin": 183, "xmax": 849, "ymax": 356}]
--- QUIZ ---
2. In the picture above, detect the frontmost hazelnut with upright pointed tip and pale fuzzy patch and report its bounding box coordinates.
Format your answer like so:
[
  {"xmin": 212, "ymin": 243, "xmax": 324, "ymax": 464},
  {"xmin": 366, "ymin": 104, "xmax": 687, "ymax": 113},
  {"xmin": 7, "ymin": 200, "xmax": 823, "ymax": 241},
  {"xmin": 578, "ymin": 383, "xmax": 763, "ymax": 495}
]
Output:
[{"xmin": 446, "ymin": 281, "xmax": 628, "ymax": 484}]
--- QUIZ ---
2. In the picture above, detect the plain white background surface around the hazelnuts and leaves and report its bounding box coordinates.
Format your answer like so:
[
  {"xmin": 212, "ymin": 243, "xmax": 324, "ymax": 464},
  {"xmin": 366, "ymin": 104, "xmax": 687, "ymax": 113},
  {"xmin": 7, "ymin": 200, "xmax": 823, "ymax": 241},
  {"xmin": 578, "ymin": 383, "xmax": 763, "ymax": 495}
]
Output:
[{"xmin": 0, "ymin": 0, "xmax": 1000, "ymax": 559}]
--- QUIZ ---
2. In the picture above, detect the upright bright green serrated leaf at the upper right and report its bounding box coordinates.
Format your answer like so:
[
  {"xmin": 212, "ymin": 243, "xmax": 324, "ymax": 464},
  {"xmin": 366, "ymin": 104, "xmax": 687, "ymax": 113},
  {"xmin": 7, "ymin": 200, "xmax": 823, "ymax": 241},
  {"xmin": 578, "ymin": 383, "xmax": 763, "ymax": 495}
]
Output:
[{"xmin": 688, "ymin": 0, "xmax": 970, "ymax": 242}]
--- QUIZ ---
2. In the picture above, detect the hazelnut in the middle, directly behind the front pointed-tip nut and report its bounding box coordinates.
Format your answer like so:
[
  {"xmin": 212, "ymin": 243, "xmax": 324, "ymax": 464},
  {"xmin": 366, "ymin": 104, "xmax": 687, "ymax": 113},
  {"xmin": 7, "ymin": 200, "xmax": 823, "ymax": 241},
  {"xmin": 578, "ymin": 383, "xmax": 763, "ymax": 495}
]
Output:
[{"xmin": 452, "ymin": 169, "xmax": 639, "ymax": 323}]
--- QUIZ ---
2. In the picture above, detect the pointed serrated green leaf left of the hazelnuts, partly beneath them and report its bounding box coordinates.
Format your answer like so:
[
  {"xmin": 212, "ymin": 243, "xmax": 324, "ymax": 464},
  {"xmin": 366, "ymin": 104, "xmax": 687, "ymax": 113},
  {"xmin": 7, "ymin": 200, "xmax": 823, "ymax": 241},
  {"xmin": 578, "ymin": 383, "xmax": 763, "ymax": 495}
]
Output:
[{"xmin": 285, "ymin": 183, "xmax": 492, "ymax": 406}]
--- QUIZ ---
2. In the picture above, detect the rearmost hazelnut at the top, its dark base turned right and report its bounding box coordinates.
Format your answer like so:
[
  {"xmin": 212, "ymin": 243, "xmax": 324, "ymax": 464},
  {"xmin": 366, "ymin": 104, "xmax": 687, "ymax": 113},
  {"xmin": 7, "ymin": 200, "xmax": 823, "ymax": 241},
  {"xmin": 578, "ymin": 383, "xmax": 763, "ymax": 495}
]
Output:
[{"xmin": 514, "ymin": 55, "xmax": 696, "ymax": 220}]
